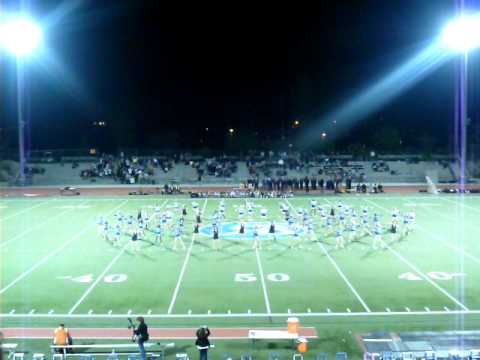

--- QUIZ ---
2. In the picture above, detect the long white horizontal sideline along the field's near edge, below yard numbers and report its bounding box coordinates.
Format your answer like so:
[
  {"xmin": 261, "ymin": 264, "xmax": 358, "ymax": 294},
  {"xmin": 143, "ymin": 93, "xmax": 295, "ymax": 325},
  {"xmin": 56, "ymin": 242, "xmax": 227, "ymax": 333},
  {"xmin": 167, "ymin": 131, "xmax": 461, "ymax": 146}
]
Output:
[{"xmin": 0, "ymin": 310, "xmax": 480, "ymax": 319}]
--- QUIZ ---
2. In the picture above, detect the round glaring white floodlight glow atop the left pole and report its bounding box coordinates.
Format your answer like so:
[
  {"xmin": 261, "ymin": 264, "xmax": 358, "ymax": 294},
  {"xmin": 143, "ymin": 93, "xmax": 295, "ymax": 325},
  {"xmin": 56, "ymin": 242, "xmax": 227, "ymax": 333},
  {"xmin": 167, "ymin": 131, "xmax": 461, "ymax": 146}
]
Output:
[{"xmin": 0, "ymin": 18, "xmax": 43, "ymax": 58}]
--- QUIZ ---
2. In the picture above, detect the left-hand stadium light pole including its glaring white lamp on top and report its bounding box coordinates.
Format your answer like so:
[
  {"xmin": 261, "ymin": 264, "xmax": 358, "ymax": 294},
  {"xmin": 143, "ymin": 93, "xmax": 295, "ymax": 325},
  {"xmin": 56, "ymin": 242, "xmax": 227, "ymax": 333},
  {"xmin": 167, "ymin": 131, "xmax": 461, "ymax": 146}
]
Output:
[{"xmin": 0, "ymin": 16, "xmax": 43, "ymax": 186}]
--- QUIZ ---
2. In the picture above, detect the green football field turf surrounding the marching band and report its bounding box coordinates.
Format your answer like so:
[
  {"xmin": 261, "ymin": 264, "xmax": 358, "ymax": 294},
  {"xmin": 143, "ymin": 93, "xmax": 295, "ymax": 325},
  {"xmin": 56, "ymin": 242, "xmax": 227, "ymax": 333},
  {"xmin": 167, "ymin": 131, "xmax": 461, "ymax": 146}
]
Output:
[{"xmin": 0, "ymin": 195, "xmax": 480, "ymax": 357}]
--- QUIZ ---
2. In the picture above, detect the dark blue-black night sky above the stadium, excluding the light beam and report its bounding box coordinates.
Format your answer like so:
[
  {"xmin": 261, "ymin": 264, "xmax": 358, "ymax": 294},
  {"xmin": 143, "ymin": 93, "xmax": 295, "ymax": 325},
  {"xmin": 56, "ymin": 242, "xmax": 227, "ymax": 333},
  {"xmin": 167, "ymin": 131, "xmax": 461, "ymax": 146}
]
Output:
[{"xmin": 0, "ymin": 0, "xmax": 478, "ymax": 150}]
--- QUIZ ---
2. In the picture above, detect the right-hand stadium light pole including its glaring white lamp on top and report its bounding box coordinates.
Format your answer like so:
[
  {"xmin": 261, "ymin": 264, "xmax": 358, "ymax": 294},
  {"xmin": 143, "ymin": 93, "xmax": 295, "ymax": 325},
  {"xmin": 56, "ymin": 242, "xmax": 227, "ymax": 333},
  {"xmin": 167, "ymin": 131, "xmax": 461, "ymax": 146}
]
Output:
[{"xmin": 442, "ymin": 14, "xmax": 480, "ymax": 191}]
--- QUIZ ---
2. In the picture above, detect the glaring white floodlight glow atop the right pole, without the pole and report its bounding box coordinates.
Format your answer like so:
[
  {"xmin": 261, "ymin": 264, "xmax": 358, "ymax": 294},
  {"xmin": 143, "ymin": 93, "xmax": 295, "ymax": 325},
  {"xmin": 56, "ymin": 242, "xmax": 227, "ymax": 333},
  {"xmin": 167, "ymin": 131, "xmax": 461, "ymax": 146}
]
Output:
[{"xmin": 442, "ymin": 14, "xmax": 480, "ymax": 52}]
